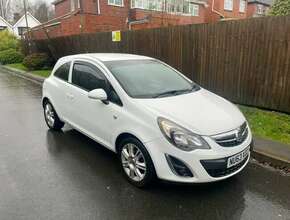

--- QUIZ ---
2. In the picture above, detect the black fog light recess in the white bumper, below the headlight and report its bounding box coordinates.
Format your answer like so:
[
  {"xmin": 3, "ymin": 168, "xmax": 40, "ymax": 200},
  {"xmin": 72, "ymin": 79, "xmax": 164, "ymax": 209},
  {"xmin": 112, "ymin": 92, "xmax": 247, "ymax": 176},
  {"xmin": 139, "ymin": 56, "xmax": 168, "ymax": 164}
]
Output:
[{"xmin": 165, "ymin": 154, "xmax": 193, "ymax": 177}]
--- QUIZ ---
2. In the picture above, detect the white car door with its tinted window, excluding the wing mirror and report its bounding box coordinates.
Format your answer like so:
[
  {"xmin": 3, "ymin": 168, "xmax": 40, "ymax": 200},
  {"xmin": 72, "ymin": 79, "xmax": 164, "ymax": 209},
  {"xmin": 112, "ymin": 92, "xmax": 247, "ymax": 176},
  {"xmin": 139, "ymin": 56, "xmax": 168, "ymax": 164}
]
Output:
[{"xmin": 70, "ymin": 61, "xmax": 122, "ymax": 148}]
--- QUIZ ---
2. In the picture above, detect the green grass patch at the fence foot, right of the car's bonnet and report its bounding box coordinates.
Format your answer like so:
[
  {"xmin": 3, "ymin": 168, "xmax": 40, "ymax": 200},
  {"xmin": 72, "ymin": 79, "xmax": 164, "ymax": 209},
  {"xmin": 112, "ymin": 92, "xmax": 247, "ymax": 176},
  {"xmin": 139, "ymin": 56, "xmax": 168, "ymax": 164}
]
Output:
[{"xmin": 239, "ymin": 106, "xmax": 290, "ymax": 145}]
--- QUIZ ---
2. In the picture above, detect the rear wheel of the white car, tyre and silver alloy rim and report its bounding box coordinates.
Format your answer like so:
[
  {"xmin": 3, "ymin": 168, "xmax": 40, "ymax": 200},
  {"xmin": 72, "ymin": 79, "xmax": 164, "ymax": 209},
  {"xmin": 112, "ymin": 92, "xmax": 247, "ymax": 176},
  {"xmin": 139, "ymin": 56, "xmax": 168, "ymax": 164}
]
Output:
[{"xmin": 43, "ymin": 101, "xmax": 64, "ymax": 131}]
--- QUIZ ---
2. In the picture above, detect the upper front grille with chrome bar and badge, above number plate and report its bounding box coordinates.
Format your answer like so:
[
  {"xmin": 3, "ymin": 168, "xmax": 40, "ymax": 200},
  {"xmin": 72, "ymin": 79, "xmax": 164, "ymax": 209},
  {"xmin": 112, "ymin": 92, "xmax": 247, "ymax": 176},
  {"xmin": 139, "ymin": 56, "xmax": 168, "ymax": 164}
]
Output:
[{"xmin": 212, "ymin": 122, "xmax": 249, "ymax": 147}]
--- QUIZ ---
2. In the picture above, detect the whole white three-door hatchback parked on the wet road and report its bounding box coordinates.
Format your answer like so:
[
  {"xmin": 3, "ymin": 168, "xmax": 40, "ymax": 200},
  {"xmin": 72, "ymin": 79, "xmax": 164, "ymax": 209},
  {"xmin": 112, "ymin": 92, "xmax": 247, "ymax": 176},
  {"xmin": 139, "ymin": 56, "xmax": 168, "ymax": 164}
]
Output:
[{"xmin": 42, "ymin": 54, "xmax": 252, "ymax": 187}]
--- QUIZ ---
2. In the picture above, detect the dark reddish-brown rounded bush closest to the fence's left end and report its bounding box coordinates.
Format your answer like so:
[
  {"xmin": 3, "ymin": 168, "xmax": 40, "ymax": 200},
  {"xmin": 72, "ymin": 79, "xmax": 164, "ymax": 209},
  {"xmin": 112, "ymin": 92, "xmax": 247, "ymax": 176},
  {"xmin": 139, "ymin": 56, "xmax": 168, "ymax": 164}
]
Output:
[{"xmin": 23, "ymin": 53, "xmax": 51, "ymax": 70}]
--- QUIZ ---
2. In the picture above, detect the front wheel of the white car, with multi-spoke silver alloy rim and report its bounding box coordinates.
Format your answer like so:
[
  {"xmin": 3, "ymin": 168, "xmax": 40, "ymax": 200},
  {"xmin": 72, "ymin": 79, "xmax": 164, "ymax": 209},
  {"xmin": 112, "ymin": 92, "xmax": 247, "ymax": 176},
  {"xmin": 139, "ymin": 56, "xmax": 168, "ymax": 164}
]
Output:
[{"xmin": 118, "ymin": 137, "xmax": 156, "ymax": 188}]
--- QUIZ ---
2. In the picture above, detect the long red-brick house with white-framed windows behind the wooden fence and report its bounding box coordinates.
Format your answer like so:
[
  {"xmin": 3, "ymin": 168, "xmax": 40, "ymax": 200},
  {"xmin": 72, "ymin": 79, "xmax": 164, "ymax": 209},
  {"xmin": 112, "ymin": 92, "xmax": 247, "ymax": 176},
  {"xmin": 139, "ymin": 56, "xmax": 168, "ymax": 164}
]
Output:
[{"xmin": 32, "ymin": 0, "xmax": 254, "ymax": 39}]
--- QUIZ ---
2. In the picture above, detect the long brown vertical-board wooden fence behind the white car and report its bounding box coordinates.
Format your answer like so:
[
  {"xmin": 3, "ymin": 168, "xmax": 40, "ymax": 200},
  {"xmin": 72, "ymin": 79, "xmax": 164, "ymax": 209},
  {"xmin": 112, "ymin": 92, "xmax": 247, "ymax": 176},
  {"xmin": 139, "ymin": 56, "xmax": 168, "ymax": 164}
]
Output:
[{"xmin": 27, "ymin": 16, "xmax": 290, "ymax": 113}]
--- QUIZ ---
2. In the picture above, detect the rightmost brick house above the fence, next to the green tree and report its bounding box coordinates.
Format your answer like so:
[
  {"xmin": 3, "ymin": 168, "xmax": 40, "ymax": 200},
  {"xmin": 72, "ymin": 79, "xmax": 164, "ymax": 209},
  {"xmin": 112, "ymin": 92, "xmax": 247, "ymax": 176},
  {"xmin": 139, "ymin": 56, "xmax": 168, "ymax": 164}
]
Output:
[{"xmin": 247, "ymin": 0, "xmax": 273, "ymax": 17}]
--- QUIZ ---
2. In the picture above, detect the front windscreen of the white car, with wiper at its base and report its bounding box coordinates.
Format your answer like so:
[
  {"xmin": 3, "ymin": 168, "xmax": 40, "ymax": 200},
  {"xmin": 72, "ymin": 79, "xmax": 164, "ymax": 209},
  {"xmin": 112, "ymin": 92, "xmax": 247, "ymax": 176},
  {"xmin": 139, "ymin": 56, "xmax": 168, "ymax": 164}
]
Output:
[{"xmin": 104, "ymin": 59, "xmax": 199, "ymax": 98}]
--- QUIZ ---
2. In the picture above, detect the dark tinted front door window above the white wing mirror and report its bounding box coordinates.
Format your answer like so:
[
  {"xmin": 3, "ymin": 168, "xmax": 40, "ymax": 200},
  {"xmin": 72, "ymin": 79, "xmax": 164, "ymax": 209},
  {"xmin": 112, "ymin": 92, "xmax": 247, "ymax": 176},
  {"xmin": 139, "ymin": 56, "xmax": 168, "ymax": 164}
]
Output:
[{"xmin": 72, "ymin": 62, "xmax": 107, "ymax": 91}]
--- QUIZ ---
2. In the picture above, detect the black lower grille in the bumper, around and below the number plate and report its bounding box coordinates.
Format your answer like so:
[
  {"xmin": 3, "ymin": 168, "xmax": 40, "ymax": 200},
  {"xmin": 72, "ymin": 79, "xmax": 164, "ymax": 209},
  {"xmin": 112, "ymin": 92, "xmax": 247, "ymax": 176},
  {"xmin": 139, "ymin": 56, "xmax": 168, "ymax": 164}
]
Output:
[{"xmin": 200, "ymin": 156, "xmax": 249, "ymax": 178}]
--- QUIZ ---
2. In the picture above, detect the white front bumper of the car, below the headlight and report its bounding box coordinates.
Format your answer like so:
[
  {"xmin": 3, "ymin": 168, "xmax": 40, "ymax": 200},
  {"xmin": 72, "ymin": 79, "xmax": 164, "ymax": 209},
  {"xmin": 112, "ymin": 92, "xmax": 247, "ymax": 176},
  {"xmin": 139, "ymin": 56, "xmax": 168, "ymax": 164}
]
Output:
[{"xmin": 145, "ymin": 129, "xmax": 252, "ymax": 183}]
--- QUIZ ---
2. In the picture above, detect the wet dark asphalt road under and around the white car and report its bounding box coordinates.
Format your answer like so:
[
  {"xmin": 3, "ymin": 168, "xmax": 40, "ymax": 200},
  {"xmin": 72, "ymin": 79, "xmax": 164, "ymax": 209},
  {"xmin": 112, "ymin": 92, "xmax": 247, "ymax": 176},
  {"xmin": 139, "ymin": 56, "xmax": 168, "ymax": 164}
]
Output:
[{"xmin": 0, "ymin": 70, "xmax": 290, "ymax": 220}]
